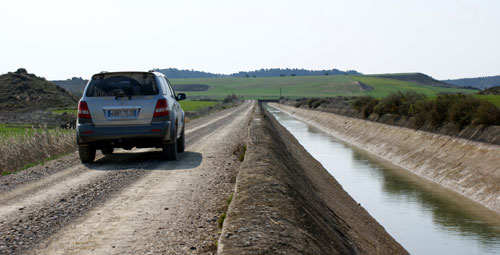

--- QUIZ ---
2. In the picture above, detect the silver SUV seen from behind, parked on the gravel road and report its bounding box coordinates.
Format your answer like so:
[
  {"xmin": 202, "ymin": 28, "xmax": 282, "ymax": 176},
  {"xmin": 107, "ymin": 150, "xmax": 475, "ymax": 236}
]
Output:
[{"xmin": 76, "ymin": 72, "xmax": 186, "ymax": 163}]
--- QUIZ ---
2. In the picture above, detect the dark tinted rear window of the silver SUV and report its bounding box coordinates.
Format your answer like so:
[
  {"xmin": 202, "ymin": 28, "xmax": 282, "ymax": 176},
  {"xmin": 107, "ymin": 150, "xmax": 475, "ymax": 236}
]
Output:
[{"xmin": 86, "ymin": 73, "xmax": 159, "ymax": 97}]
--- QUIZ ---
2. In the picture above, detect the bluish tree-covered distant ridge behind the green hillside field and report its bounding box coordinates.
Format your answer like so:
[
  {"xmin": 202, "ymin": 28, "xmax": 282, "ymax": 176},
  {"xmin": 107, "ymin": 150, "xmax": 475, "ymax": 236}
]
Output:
[{"xmin": 155, "ymin": 68, "xmax": 361, "ymax": 79}]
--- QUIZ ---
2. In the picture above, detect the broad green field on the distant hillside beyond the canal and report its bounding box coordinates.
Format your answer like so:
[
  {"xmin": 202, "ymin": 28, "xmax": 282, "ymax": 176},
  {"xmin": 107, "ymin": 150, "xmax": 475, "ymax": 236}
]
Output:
[{"xmin": 171, "ymin": 75, "xmax": 475, "ymax": 99}]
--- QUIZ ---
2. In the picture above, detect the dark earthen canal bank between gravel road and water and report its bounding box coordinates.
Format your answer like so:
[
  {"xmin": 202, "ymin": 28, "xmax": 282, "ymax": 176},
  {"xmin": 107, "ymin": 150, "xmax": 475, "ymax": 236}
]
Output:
[{"xmin": 218, "ymin": 108, "xmax": 407, "ymax": 254}]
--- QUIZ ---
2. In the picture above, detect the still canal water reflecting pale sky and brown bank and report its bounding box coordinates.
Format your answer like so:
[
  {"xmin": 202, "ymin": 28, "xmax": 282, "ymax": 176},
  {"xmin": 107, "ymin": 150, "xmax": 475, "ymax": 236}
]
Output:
[{"xmin": 266, "ymin": 106, "xmax": 500, "ymax": 255}]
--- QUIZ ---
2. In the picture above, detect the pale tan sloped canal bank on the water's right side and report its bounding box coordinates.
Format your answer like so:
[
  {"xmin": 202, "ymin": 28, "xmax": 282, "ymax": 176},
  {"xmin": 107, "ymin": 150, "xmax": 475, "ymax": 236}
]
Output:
[{"xmin": 272, "ymin": 104, "xmax": 500, "ymax": 213}]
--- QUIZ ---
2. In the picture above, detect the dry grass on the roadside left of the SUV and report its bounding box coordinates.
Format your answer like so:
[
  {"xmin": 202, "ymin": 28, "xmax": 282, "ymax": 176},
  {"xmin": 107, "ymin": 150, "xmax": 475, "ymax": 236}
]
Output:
[{"xmin": 0, "ymin": 129, "xmax": 76, "ymax": 175}]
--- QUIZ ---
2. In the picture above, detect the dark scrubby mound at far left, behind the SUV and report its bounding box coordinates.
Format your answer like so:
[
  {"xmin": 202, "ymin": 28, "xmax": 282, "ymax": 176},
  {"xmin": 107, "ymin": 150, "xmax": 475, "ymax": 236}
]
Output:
[{"xmin": 0, "ymin": 68, "xmax": 78, "ymax": 112}]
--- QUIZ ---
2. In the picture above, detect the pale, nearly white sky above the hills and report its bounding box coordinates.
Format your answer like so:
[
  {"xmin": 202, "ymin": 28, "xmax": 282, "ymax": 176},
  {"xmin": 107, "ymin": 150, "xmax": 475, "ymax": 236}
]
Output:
[{"xmin": 0, "ymin": 0, "xmax": 500, "ymax": 80}]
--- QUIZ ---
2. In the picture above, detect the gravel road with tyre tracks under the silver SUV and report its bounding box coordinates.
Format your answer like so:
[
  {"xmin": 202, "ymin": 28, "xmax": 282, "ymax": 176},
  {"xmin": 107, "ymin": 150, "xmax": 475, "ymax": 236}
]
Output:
[{"xmin": 0, "ymin": 102, "xmax": 255, "ymax": 254}]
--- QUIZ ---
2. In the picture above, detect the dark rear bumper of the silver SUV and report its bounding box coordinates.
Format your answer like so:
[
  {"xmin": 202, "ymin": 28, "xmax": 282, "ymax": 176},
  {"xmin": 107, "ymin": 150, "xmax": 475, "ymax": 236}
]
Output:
[{"xmin": 76, "ymin": 122, "xmax": 173, "ymax": 145}]
